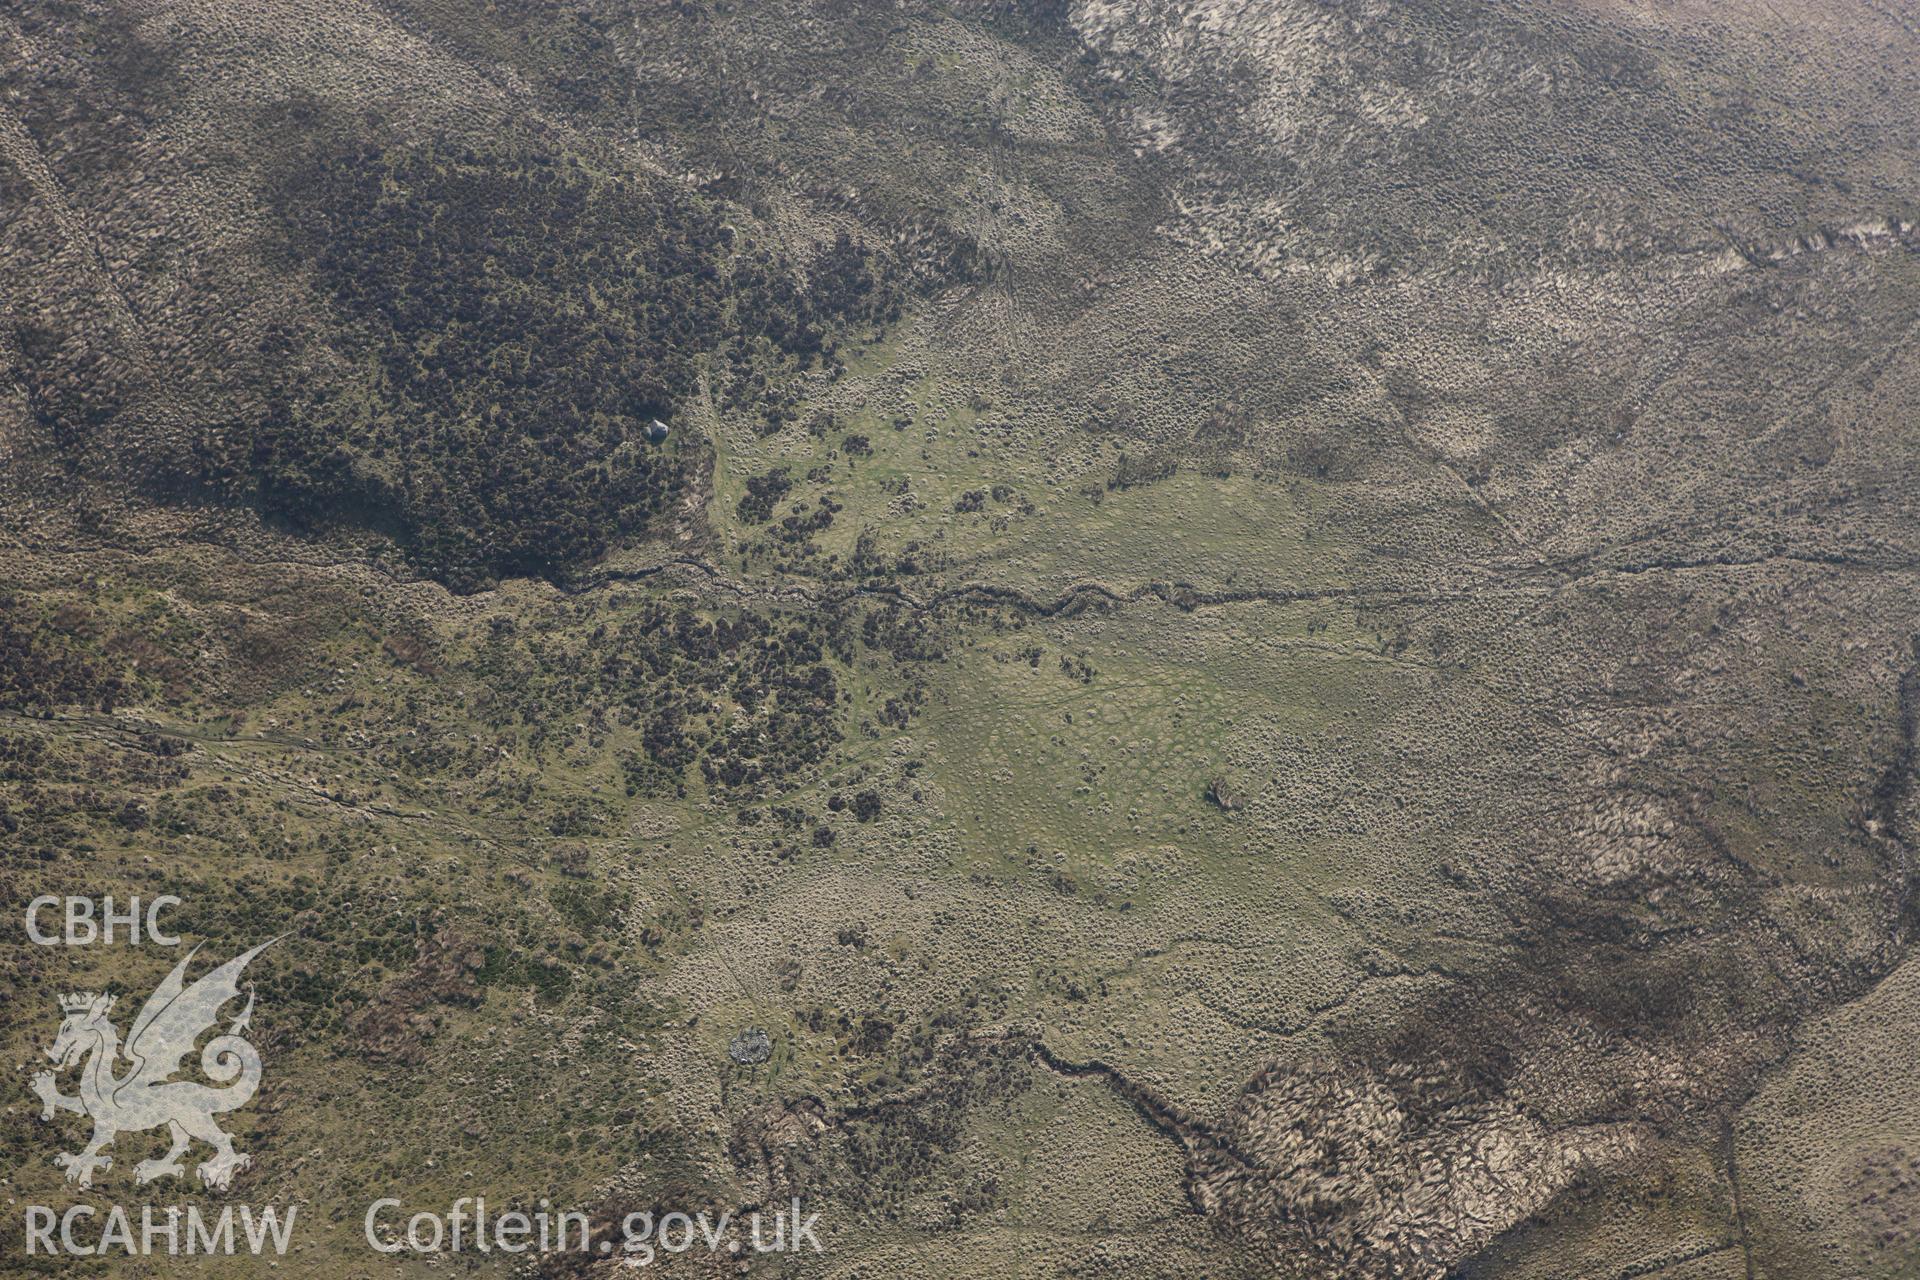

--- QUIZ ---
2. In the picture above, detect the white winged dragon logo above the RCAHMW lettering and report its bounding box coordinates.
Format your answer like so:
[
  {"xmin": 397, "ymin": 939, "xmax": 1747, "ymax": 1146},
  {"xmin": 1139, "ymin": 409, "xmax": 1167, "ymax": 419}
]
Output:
[{"xmin": 33, "ymin": 938, "xmax": 280, "ymax": 1192}]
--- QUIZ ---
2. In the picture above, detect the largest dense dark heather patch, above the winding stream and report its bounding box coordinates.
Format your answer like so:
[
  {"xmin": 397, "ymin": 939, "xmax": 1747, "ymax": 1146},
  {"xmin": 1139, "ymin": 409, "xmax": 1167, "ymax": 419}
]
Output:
[{"xmin": 204, "ymin": 130, "xmax": 899, "ymax": 589}]
